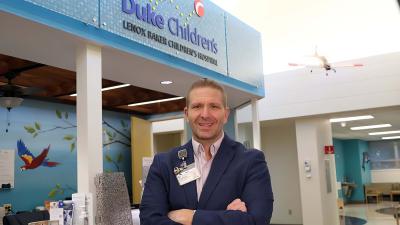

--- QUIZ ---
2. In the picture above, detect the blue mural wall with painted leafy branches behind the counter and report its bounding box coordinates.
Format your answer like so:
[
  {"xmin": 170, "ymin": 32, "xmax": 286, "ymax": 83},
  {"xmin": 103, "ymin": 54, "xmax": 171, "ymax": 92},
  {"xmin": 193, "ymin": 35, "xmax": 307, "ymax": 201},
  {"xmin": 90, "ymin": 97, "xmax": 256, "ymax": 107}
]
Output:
[{"xmin": 0, "ymin": 100, "xmax": 132, "ymax": 211}]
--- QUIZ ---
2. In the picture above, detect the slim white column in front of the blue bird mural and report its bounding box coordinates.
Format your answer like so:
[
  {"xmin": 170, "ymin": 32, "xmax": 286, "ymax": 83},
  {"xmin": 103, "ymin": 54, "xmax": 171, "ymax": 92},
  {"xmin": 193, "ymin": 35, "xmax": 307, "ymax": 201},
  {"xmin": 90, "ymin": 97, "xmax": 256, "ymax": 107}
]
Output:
[{"xmin": 76, "ymin": 45, "xmax": 103, "ymax": 225}]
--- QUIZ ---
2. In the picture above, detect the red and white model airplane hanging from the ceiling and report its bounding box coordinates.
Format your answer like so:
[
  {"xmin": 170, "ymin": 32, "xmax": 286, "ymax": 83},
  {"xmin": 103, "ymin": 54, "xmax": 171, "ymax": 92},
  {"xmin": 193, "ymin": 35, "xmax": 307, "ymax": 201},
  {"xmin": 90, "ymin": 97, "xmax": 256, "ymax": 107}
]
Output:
[{"xmin": 289, "ymin": 48, "xmax": 364, "ymax": 76}]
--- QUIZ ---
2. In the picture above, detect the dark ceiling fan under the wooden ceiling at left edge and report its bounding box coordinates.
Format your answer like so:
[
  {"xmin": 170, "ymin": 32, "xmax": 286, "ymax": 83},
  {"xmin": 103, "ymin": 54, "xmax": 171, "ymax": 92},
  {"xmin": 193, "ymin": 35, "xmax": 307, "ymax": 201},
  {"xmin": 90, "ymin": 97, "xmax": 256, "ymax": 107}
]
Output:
[{"xmin": 0, "ymin": 63, "xmax": 45, "ymax": 111}]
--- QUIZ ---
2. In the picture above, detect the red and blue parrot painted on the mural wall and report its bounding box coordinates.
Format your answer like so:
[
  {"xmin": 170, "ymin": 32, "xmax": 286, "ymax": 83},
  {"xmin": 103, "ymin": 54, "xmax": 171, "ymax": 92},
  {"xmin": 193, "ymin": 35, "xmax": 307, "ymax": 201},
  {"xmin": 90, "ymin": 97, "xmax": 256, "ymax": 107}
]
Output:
[{"xmin": 17, "ymin": 140, "xmax": 59, "ymax": 171}]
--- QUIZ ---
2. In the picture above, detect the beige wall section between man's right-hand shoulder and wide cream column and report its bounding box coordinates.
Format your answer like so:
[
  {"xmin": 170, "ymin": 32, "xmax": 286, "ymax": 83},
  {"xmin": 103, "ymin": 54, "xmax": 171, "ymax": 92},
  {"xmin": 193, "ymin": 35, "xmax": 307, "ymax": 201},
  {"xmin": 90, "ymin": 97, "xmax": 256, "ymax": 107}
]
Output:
[{"xmin": 261, "ymin": 121, "xmax": 303, "ymax": 224}]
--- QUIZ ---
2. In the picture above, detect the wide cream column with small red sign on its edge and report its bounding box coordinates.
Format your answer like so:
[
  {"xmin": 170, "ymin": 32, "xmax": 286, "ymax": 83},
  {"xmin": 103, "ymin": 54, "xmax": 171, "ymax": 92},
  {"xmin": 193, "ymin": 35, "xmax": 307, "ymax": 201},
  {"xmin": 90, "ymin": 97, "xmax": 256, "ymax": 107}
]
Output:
[{"xmin": 296, "ymin": 118, "xmax": 339, "ymax": 225}]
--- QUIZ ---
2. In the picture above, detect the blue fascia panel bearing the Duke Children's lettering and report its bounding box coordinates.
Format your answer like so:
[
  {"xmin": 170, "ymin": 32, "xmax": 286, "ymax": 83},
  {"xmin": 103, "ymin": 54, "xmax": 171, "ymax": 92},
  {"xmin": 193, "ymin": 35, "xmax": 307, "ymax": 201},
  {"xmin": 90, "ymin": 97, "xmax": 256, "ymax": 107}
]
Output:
[{"xmin": 100, "ymin": 0, "xmax": 227, "ymax": 74}]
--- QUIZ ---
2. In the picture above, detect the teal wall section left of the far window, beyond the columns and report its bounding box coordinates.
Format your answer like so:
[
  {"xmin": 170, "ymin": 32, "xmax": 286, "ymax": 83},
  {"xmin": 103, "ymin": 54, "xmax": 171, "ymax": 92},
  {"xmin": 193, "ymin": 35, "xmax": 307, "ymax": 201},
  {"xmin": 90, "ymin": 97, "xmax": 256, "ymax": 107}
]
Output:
[{"xmin": 333, "ymin": 139, "xmax": 371, "ymax": 202}]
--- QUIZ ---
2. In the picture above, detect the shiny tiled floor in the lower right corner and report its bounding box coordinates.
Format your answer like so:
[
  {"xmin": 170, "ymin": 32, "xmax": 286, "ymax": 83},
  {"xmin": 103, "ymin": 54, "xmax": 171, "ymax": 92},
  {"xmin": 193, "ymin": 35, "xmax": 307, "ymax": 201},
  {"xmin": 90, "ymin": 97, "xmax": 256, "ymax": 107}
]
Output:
[{"xmin": 340, "ymin": 202, "xmax": 397, "ymax": 225}]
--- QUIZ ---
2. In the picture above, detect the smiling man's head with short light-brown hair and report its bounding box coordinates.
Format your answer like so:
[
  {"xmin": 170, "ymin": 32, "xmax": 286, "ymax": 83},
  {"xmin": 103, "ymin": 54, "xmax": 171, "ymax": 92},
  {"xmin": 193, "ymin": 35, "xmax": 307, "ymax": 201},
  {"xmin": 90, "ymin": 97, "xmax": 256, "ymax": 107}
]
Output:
[{"xmin": 184, "ymin": 79, "xmax": 229, "ymax": 145}]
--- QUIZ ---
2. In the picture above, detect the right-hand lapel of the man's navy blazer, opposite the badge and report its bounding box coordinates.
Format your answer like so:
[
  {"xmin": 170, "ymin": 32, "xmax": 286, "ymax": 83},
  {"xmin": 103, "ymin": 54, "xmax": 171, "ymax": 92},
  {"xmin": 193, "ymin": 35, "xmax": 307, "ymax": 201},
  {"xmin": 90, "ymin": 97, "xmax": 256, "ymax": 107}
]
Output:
[{"xmin": 198, "ymin": 135, "xmax": 235, "ymax": 209}]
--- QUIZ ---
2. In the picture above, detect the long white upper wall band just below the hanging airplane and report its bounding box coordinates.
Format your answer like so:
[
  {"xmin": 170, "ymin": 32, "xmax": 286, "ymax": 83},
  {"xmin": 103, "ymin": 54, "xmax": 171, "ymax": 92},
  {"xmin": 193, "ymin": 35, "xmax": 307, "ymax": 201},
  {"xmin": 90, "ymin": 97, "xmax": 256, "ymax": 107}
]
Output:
[{"xmin": 259, "ymin": 52, "xmax": 400, "ymax": 121}]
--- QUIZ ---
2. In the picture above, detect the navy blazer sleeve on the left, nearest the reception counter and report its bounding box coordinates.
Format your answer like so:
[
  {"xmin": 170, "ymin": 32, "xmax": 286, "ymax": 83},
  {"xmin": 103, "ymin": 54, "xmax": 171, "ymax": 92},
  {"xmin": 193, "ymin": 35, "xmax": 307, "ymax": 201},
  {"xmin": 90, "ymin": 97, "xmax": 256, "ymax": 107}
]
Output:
[{"xmin": 139, "ymin": 155, "xmax": 179, "ymax": 225}]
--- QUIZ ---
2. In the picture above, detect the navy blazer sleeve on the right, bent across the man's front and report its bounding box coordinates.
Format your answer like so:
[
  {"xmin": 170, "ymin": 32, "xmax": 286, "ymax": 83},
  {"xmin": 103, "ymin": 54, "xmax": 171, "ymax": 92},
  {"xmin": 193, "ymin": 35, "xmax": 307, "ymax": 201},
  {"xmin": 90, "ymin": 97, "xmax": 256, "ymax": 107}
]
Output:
[{"xmin": 193, "ymin": 150, "xmax": 274, "ymax": 225}]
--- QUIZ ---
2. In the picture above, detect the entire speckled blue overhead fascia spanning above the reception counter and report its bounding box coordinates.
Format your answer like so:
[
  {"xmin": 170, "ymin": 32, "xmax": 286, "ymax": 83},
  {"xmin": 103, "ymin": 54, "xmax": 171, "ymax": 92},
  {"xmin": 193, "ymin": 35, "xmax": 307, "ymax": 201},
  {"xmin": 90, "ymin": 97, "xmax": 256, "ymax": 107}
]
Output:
[{"xmin": 12, "ymin": 0, "xmax": 264, "ymax": 92}]
